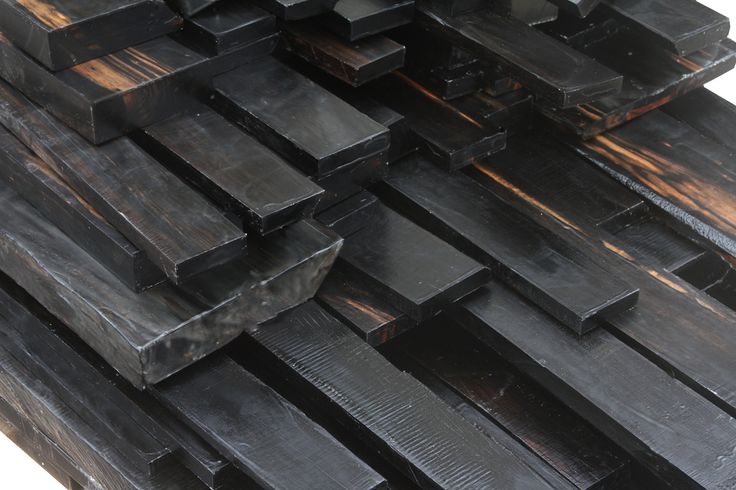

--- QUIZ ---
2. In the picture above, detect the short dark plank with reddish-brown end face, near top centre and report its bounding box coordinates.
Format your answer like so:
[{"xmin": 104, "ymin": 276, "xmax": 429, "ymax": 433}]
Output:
[{"xmin": 283, "ymin": 23, "xmax": 406, "ymax": 87}]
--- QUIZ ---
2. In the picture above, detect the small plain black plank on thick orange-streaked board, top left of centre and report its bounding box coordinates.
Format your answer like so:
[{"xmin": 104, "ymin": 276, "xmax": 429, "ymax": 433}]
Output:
[{"xmin": 181, "ymin": 0, "xmax": 276, "ymax": 56}]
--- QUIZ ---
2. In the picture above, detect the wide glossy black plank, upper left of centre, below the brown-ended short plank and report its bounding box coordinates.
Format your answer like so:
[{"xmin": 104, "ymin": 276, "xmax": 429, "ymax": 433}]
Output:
[{"xmin": 214, "ymin": 58, "xmax": 389, "ymax": 177}]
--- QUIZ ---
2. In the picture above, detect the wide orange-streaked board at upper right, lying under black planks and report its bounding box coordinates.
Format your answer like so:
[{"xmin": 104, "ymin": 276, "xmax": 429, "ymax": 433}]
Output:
[{"xmin": 538, "ymin": 31, "xmax": 736, "ymax": 139}]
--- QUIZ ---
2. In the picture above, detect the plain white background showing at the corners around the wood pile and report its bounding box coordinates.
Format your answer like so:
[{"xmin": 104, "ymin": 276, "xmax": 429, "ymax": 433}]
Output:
[{"xmin": 0, "ymin": 0, "xmax": 736, "ymax": 490}]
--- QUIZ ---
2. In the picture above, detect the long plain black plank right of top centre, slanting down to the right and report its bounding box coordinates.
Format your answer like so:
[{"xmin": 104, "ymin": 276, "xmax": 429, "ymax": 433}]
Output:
[{"xmin": 417, "ymin": 4, "xmax": 623, "ymax": 107}]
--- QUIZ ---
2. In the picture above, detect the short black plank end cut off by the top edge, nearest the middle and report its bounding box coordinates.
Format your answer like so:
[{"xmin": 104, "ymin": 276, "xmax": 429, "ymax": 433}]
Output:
[{"xmin": 322, "ymin": 0, "xmax": 414, "ymax": 42}]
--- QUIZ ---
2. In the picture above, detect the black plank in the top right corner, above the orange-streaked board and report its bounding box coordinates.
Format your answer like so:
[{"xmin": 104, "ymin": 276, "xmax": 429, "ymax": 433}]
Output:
[{"xmin": 600, "ymin": 0, "xmax": 730, "ymax": 55}]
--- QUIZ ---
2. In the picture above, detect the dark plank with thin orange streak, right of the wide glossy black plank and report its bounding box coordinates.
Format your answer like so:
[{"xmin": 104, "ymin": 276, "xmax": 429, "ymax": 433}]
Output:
[{"xmin": 371, "ymin": 73, "xmax": 506, "ymax": 170}]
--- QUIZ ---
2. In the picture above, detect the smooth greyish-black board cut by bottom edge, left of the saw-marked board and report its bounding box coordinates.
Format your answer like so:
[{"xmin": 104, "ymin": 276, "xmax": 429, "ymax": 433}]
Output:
[{"xmin": 154, "ymin": 355, "xmax": 385, "ymax": 490}]
